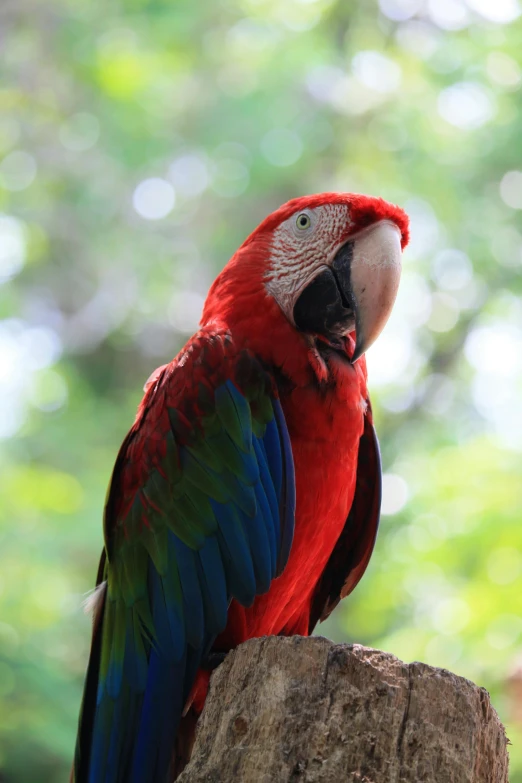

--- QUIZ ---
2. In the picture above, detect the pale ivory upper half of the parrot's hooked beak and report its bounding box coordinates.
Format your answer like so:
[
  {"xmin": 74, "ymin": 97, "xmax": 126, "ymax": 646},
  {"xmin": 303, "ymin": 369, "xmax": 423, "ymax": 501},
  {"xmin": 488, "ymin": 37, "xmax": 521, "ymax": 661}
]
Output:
[{"xmin": 350, "ymin": 220, "xmax": 401, "ymax": 363}]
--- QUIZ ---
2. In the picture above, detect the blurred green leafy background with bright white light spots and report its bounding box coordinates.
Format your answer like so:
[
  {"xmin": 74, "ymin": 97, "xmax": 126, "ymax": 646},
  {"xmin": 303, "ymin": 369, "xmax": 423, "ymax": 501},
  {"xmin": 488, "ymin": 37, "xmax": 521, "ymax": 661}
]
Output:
[{"xmin": 0, "ymin": 0, "xmax": 522, "ymax": 783}]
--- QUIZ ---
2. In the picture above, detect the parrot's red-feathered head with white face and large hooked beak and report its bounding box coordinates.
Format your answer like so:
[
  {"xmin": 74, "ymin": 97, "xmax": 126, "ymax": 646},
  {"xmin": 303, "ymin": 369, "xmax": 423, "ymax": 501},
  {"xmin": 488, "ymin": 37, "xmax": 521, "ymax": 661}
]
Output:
[{"xmin": 203, "ymin": 193, "xmax": 408, "ymax": 382}]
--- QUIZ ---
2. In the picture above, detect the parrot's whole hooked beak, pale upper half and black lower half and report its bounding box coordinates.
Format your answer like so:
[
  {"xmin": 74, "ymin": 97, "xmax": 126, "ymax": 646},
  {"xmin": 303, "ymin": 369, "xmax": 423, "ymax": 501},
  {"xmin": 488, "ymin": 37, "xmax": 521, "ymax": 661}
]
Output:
[{"xmin": 293, "ymin": 220, "xmax": 401, "ymax": 363}]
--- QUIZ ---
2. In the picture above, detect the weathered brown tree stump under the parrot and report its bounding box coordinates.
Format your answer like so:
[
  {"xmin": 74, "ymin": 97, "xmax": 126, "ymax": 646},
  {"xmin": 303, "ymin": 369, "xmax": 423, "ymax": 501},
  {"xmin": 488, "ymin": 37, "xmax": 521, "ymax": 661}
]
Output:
[{"xmin": 178, "ymin": 636, "xmax": 508, "ymax": 783}]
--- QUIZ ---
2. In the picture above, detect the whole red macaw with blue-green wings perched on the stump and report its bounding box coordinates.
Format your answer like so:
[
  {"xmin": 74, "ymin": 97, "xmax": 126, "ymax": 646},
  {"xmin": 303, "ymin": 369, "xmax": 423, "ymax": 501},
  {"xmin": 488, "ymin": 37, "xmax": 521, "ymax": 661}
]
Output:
[{"xmin": 71, "ymin": 193, "xmax": 409, "ymax": 783}]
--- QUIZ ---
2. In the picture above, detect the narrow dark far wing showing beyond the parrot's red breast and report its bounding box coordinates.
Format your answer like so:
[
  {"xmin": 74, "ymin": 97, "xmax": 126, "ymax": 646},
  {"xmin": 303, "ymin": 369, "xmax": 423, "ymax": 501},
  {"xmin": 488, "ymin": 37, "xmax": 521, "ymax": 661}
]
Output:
[{"xmin": 309, "ymin": 400, "xmax": 382, "ymax": 633}]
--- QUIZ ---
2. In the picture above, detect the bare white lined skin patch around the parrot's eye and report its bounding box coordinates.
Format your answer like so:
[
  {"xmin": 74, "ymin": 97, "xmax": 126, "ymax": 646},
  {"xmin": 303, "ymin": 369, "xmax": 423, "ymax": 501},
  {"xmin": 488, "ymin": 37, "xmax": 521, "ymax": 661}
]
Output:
[{"xmin": 265, "ymin": 204, "xmax": 351, "ymax": 321}]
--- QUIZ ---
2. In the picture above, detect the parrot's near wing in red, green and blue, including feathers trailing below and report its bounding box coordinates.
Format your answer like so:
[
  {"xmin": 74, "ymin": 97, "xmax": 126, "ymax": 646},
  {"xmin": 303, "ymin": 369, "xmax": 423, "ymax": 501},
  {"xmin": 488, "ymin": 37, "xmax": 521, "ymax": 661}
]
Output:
[{"xmin": 73, "ymin": 331, "xmax": 295, "ymax": 783}]
